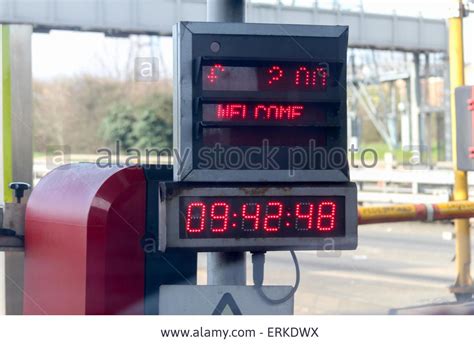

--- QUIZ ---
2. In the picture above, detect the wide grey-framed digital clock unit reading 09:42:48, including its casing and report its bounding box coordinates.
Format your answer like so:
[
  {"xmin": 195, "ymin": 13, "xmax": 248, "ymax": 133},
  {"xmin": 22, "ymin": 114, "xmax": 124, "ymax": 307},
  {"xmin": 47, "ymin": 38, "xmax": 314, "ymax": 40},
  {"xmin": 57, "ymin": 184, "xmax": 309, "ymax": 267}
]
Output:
[{"xmin": 158, "ymin": 181, "xmax": 357, "ymax": 251}]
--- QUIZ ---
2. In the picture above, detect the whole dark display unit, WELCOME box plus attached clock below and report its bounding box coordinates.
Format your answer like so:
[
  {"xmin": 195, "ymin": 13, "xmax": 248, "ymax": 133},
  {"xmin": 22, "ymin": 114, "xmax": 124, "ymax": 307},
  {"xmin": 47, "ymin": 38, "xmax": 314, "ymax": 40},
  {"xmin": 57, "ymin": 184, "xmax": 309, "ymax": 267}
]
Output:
[{"xmin": 168, "ymin": 22, "xmax": 358, "ymax": 252}]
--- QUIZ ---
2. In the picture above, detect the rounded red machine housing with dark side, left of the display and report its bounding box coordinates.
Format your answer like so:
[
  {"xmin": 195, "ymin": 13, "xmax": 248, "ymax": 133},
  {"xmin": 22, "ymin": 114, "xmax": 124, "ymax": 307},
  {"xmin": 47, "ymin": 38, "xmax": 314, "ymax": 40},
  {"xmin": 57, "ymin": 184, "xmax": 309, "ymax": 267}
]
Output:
[{"xmin": 24, "ymin": 163, "xmax": 196, "ymax": 314}]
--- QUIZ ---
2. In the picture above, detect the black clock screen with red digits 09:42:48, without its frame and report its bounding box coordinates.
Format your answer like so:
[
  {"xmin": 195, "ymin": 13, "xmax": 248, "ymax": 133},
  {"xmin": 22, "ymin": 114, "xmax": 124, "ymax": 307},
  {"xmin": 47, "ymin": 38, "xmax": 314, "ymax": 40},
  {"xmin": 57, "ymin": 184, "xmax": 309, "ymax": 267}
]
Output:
[{"xmin": 179, "ymin": 196, "xmax": 345, "ymax": 239}]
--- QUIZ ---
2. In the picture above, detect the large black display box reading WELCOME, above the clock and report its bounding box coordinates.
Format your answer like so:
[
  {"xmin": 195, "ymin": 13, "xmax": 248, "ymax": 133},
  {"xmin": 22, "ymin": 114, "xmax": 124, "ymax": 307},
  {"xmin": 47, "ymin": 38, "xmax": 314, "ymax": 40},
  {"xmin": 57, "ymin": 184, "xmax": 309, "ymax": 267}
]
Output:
[{"xmin": 173, "ymin": 22, "xmax": 349, "ymax": 182}]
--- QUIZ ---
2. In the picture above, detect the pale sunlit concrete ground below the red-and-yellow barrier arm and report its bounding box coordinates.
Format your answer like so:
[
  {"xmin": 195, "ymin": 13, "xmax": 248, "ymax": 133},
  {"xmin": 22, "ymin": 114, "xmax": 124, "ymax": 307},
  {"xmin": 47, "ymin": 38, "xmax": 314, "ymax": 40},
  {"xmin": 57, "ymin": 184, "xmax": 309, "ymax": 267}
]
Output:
[{"xmin": 198, "ymin": 222, "xmax": 474, "ymax": 314}]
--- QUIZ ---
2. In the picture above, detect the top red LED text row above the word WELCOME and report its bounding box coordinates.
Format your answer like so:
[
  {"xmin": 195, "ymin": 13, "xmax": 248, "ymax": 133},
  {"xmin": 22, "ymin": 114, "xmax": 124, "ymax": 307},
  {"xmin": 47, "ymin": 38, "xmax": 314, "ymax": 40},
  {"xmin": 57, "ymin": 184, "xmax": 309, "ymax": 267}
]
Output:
[{"xmin": 202, "ymin": 62, "xmax": 330, "ymax": 92}]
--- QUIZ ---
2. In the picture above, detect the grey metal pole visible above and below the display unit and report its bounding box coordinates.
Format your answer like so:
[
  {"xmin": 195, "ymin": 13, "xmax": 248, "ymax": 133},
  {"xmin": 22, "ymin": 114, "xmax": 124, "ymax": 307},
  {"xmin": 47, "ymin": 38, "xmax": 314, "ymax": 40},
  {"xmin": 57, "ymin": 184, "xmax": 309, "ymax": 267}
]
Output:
[{"xmin": 207, "ymin": 0, "xmax": 247, "ymax": 285}]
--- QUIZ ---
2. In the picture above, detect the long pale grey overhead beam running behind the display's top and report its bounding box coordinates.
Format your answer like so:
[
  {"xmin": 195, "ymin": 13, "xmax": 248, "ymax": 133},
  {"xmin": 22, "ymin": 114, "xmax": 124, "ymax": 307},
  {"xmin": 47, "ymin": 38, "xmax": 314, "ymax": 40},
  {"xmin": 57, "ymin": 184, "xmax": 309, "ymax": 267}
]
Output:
[{"xmin": 0, "ymin": 0, "xmax": 447, "ymax": 52}]
